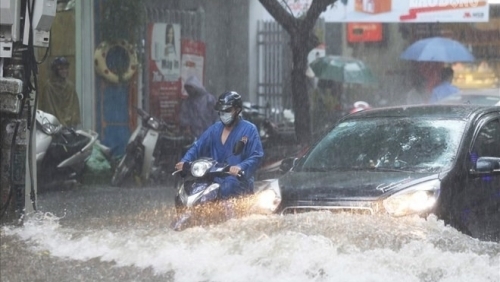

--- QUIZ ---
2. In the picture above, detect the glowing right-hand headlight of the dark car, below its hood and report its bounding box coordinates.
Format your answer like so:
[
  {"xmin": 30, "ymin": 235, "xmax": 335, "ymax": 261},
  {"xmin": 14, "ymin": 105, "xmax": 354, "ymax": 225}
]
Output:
[{"xmin": 383, "ymin": 179, "xmax": 441, "ymax": 216}]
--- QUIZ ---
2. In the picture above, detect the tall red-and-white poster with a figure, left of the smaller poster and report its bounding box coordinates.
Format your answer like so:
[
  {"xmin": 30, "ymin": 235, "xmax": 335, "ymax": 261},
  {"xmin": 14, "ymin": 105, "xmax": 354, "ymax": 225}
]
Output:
[{"xmin": 148, "ymin": 23, "xmax": 182, "ymax": 123}]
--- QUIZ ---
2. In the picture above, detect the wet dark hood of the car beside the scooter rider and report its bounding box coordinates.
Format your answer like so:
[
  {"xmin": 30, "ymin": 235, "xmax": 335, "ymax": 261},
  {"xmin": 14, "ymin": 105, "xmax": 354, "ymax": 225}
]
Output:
[{"xmin": 279, "ymin": 171, "xmax": 438, "ymax": 201}]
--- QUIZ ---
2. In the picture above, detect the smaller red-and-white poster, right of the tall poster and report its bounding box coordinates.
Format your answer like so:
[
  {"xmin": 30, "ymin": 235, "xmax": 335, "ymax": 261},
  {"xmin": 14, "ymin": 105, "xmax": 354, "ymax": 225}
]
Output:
[{"xmin": 181, "ymin": 39, "xmax": 205, "ymax": 98}]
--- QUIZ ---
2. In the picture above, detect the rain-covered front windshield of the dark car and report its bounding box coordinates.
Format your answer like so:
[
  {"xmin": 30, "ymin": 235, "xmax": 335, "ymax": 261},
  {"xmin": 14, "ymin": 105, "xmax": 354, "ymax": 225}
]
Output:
[{"xmin": 299, "ymin": 118, "xmax": 465, "ymax": 172}]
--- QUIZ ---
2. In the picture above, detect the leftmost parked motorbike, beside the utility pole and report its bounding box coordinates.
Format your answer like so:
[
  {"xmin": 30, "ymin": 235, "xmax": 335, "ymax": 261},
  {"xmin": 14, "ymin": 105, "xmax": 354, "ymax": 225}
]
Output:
[{"xmin": 35, "ymin": 110, "xmax": 98, "ymax": 191}]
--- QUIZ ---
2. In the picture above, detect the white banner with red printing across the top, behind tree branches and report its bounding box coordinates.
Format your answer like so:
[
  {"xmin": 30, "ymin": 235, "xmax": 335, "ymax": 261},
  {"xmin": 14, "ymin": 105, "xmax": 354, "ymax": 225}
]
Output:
[{"xmin": 285, "ymin": 0, "xmax": 489, "ymax": 22}]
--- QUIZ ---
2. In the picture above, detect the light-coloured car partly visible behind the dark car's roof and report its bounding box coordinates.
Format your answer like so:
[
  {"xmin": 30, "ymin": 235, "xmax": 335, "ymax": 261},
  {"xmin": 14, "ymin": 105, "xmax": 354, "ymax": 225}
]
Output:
[{"xmin": 438, "ymin": 88, "xmax": 500, "ymax": 106}]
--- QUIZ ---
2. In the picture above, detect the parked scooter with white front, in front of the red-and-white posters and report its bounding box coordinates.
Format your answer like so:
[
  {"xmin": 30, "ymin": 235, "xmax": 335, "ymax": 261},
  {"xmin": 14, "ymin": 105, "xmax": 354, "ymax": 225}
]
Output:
[{"xmin": 111, "ymin": 108, "xmax": 193, "ymax": 186}]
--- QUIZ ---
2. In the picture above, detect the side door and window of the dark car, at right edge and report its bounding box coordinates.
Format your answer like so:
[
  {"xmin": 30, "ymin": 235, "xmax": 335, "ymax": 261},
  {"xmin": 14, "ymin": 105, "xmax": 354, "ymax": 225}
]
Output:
[{"xmin": 463, "ymin": 114, "xmax": 500, "ymax": 240}]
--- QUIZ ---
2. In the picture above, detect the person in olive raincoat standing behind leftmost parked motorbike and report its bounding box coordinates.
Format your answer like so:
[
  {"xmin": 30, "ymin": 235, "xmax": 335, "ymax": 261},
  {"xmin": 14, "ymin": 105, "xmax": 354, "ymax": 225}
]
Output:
[{"xmin": 38, "ymin": 57, "xmax": 81, "ymax": 127}]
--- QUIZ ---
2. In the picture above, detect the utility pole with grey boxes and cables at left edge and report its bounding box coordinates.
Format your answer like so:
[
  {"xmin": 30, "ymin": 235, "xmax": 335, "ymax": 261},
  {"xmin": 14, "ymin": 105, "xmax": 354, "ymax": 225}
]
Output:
[{"xmin": 0, "ymin": 0, "xmax": 57, "ymax": 224}]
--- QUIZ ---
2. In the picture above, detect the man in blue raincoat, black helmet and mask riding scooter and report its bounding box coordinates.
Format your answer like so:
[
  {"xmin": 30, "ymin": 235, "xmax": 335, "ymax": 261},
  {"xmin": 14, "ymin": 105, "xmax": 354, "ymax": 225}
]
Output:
[{"xmin": 175, "ymin": 91, "xmax": 264, "ymax": 199}]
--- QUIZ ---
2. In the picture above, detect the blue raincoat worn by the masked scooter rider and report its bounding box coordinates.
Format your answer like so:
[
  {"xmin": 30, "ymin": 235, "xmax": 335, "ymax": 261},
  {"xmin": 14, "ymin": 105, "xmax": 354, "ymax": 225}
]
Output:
[{"xmin": 181, "ymin": 119, "xmax": 264, "ymax": 199}]
